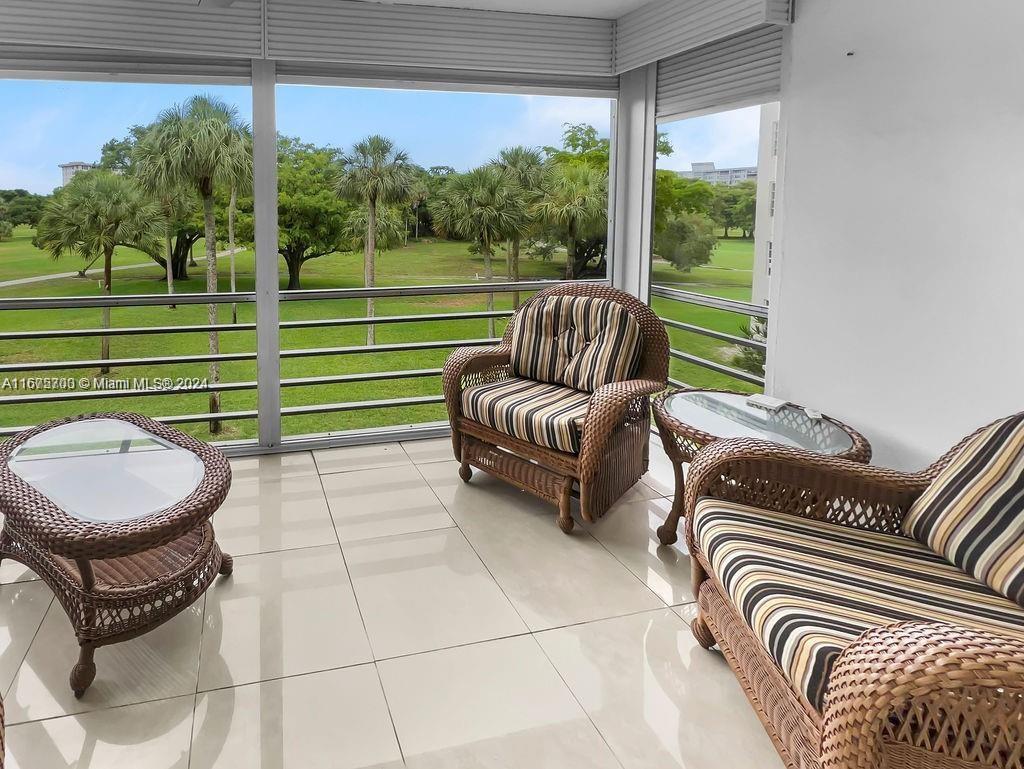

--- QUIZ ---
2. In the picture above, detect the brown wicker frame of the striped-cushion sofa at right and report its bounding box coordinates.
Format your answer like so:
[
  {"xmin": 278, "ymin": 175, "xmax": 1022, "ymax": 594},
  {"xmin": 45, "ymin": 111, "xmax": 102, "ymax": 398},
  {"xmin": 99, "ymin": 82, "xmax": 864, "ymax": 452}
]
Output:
[{"xmin": 685, "ymin": 421, "xmax": 1024, "ymax": 769}]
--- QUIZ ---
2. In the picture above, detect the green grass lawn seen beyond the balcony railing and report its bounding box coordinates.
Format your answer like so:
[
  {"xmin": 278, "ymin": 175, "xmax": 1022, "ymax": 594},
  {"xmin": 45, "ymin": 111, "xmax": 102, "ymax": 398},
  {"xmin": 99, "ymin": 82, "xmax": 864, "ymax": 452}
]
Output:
[{"xmin": 0, "ymin": 228, "xmax": 753, "ymax": 439}]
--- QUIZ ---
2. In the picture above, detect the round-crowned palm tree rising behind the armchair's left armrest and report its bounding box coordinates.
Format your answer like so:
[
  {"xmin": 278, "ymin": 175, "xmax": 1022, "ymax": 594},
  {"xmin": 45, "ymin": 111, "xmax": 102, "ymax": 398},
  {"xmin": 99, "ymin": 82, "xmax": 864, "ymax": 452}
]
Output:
[{"xmin": 434, "ymin": 166, "xmax": 529, "ymax": 337}]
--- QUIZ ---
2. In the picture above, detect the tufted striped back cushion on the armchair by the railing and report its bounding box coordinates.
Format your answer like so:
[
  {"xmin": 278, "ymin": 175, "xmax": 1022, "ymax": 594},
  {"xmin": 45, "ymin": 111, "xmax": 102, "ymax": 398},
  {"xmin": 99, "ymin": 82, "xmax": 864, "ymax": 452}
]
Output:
[{"xmin": 512, "ymin": 296, "xmax": 640, "ymax": 392}]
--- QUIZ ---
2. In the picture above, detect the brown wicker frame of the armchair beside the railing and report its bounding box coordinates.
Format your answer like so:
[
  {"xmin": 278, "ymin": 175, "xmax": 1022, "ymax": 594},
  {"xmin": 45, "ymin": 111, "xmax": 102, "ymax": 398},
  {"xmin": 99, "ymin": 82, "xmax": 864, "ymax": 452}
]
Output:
[{"xmin": 443, "ymin": 284, "xmax": 669, "ymax": 533}]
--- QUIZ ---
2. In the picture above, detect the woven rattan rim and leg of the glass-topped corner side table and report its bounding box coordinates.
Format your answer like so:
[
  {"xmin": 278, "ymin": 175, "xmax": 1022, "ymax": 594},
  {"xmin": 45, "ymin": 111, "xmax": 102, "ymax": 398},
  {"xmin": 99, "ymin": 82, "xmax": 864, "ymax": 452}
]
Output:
[{"xmin": 653, "ymin": 388, "xmax": 871, "ymax": 545}]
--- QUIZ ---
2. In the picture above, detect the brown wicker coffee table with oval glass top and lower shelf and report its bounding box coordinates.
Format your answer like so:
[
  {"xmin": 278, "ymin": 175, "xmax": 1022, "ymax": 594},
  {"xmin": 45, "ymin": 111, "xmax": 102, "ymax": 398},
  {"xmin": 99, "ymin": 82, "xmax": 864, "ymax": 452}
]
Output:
[{"xmin": 0, "ymin": 414, "xmax": 231, "ymax": 697}]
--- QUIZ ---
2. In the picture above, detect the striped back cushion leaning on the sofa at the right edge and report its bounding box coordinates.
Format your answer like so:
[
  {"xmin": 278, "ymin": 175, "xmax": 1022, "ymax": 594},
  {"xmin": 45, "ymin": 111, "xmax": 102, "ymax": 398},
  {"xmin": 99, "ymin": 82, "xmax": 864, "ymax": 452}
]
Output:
[{"xmin": 903, "ymin": 414, "xmax": 1024, "ymax": 606}]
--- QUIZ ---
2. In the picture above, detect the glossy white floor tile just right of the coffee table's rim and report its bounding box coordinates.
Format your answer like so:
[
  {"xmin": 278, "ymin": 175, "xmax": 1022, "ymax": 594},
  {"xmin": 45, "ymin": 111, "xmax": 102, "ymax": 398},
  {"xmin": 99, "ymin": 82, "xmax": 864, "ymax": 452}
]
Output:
[{"xmin": 213, "ymin": 472, "xmax": 338, "ymax": 556}]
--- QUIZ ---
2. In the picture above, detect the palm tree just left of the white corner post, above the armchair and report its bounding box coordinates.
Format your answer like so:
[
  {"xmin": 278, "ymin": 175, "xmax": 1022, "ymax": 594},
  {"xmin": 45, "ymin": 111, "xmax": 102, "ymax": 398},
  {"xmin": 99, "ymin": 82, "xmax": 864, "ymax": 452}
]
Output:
[{"xmin": 534, "ymin": 163, "xmax": 608, "ymax": 281}]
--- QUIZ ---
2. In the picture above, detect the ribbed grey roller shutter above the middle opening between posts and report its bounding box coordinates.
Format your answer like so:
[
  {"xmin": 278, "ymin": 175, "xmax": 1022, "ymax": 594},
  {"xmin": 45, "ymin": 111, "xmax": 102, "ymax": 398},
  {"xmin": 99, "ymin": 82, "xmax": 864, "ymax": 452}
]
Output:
[{"xmin": 266, "ymin": 0, "xmax": 614, "ymax": 76}]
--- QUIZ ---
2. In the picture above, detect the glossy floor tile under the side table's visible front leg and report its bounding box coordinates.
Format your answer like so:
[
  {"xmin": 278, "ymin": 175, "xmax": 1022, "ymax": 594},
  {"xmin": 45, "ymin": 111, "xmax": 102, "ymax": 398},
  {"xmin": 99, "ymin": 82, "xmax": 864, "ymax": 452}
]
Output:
[{"xmin": 590, "ymin": 499, "xmax": 693, "ymax": 606}]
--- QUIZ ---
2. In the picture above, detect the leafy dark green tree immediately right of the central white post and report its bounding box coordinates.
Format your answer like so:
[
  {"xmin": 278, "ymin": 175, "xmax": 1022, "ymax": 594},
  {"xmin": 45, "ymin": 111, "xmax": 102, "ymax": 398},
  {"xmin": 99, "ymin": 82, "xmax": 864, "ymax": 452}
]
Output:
[{"xmin": 278, "ymin": 136, "xmax": 348, "ymax": 290}]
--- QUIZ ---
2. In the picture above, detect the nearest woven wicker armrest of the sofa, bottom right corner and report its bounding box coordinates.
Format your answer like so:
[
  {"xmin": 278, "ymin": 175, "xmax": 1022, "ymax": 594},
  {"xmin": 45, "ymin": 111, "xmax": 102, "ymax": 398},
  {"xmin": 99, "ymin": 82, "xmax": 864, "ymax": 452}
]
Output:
[{"xmin": 821, "ymin": 623, "xmax": 1024, "ymax": 769}]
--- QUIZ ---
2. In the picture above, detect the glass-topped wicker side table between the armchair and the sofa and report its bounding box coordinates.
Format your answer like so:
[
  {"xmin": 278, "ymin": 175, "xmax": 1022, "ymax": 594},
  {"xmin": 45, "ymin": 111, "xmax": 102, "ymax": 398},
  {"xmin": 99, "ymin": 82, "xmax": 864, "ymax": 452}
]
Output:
[{"xmin": 652, "ymin": 389, "xmax": 871, "ymax": 545}]
